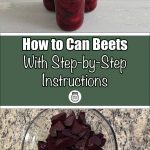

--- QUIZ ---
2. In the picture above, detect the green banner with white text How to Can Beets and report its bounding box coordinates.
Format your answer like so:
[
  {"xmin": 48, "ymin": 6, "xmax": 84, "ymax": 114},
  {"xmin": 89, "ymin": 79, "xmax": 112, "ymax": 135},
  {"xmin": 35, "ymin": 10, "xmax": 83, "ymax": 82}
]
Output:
[{"xmin": 0, "ymin": 35, "xmax": 150, "ymax": 106}]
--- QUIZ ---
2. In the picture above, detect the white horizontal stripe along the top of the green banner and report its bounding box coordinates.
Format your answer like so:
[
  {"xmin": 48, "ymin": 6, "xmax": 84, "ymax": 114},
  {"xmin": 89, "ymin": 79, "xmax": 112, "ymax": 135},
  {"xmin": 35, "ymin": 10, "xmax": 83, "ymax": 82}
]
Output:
[{"xmin": 1, "ymin": 33, "xmax": 150, "ymax": 36}]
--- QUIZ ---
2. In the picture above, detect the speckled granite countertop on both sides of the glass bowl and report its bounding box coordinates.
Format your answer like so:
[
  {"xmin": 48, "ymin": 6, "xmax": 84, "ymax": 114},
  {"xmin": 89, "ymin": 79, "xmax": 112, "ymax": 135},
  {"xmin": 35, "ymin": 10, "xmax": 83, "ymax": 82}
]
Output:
[{"xmin": 0, "ymin": 109, "xmax": 150, "ymax": 150}]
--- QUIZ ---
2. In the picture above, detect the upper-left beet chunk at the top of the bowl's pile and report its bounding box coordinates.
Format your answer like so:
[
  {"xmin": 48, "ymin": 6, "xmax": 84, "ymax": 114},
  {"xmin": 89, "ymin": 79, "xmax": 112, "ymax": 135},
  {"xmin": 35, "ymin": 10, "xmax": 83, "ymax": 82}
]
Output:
[{"xmin": 51, "ymin": 112, "xmax": 66, "ymax": 124}]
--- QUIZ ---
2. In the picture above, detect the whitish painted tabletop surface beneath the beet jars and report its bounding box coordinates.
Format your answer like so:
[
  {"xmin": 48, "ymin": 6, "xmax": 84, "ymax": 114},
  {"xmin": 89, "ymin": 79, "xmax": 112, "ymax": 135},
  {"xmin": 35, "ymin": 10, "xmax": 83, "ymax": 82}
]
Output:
[{"xmin": 0, "ymin": 0, "xmax": 150, "ymax": 33}]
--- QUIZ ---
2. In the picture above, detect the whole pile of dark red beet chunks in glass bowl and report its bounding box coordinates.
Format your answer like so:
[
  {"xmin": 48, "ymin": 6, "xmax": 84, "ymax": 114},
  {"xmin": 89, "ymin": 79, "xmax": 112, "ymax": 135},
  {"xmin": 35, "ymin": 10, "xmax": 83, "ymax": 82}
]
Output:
[{"xmin": 37, "ymin": 112, "xmax": 106, "ymax": 150}]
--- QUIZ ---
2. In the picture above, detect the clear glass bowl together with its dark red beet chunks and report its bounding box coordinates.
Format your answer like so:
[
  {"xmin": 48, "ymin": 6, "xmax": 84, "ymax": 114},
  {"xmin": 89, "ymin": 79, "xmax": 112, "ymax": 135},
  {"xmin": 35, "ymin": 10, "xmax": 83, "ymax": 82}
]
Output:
[{"xmin": 22, "ymin": 109, "xmax": 118, "ymax": 150}]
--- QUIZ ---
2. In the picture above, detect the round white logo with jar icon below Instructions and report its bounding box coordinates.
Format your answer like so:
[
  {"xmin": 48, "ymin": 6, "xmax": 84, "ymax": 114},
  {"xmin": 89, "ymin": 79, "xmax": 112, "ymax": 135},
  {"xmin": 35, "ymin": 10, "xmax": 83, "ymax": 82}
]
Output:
[{"xmin": 68, "ymin": 90, "xmax": 82, "ymax": 104}]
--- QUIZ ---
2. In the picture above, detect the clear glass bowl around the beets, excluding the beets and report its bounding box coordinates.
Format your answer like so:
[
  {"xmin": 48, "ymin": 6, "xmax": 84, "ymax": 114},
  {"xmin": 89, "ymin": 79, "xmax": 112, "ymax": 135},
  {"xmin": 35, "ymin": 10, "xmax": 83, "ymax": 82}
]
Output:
[{"xmin": 22, "ymin": 109, "xmax": 118, "ymax": 150}]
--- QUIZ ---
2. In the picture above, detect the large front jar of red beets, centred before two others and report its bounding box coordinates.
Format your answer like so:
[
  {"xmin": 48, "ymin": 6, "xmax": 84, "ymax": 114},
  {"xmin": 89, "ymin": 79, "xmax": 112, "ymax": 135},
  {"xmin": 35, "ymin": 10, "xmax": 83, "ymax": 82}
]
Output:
[{"xmin": 55, "ymin": 0, "xmax": 85, "ymax": 31}]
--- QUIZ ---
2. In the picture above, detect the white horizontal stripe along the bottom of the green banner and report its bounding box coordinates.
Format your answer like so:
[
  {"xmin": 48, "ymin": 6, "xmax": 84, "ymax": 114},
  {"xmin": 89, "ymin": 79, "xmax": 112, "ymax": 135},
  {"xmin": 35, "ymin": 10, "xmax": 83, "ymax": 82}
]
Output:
[{"xmin": 0, "ymin": 106, "xmax": 150, "ymax": 109}]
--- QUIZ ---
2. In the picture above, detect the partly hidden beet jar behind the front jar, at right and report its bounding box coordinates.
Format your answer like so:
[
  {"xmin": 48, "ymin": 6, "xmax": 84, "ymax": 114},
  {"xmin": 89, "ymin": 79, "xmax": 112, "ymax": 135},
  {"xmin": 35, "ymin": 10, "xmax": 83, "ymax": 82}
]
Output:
[{"xmin": 85, "ymin": 0, "xmax": 97, "ymax": 12}]
